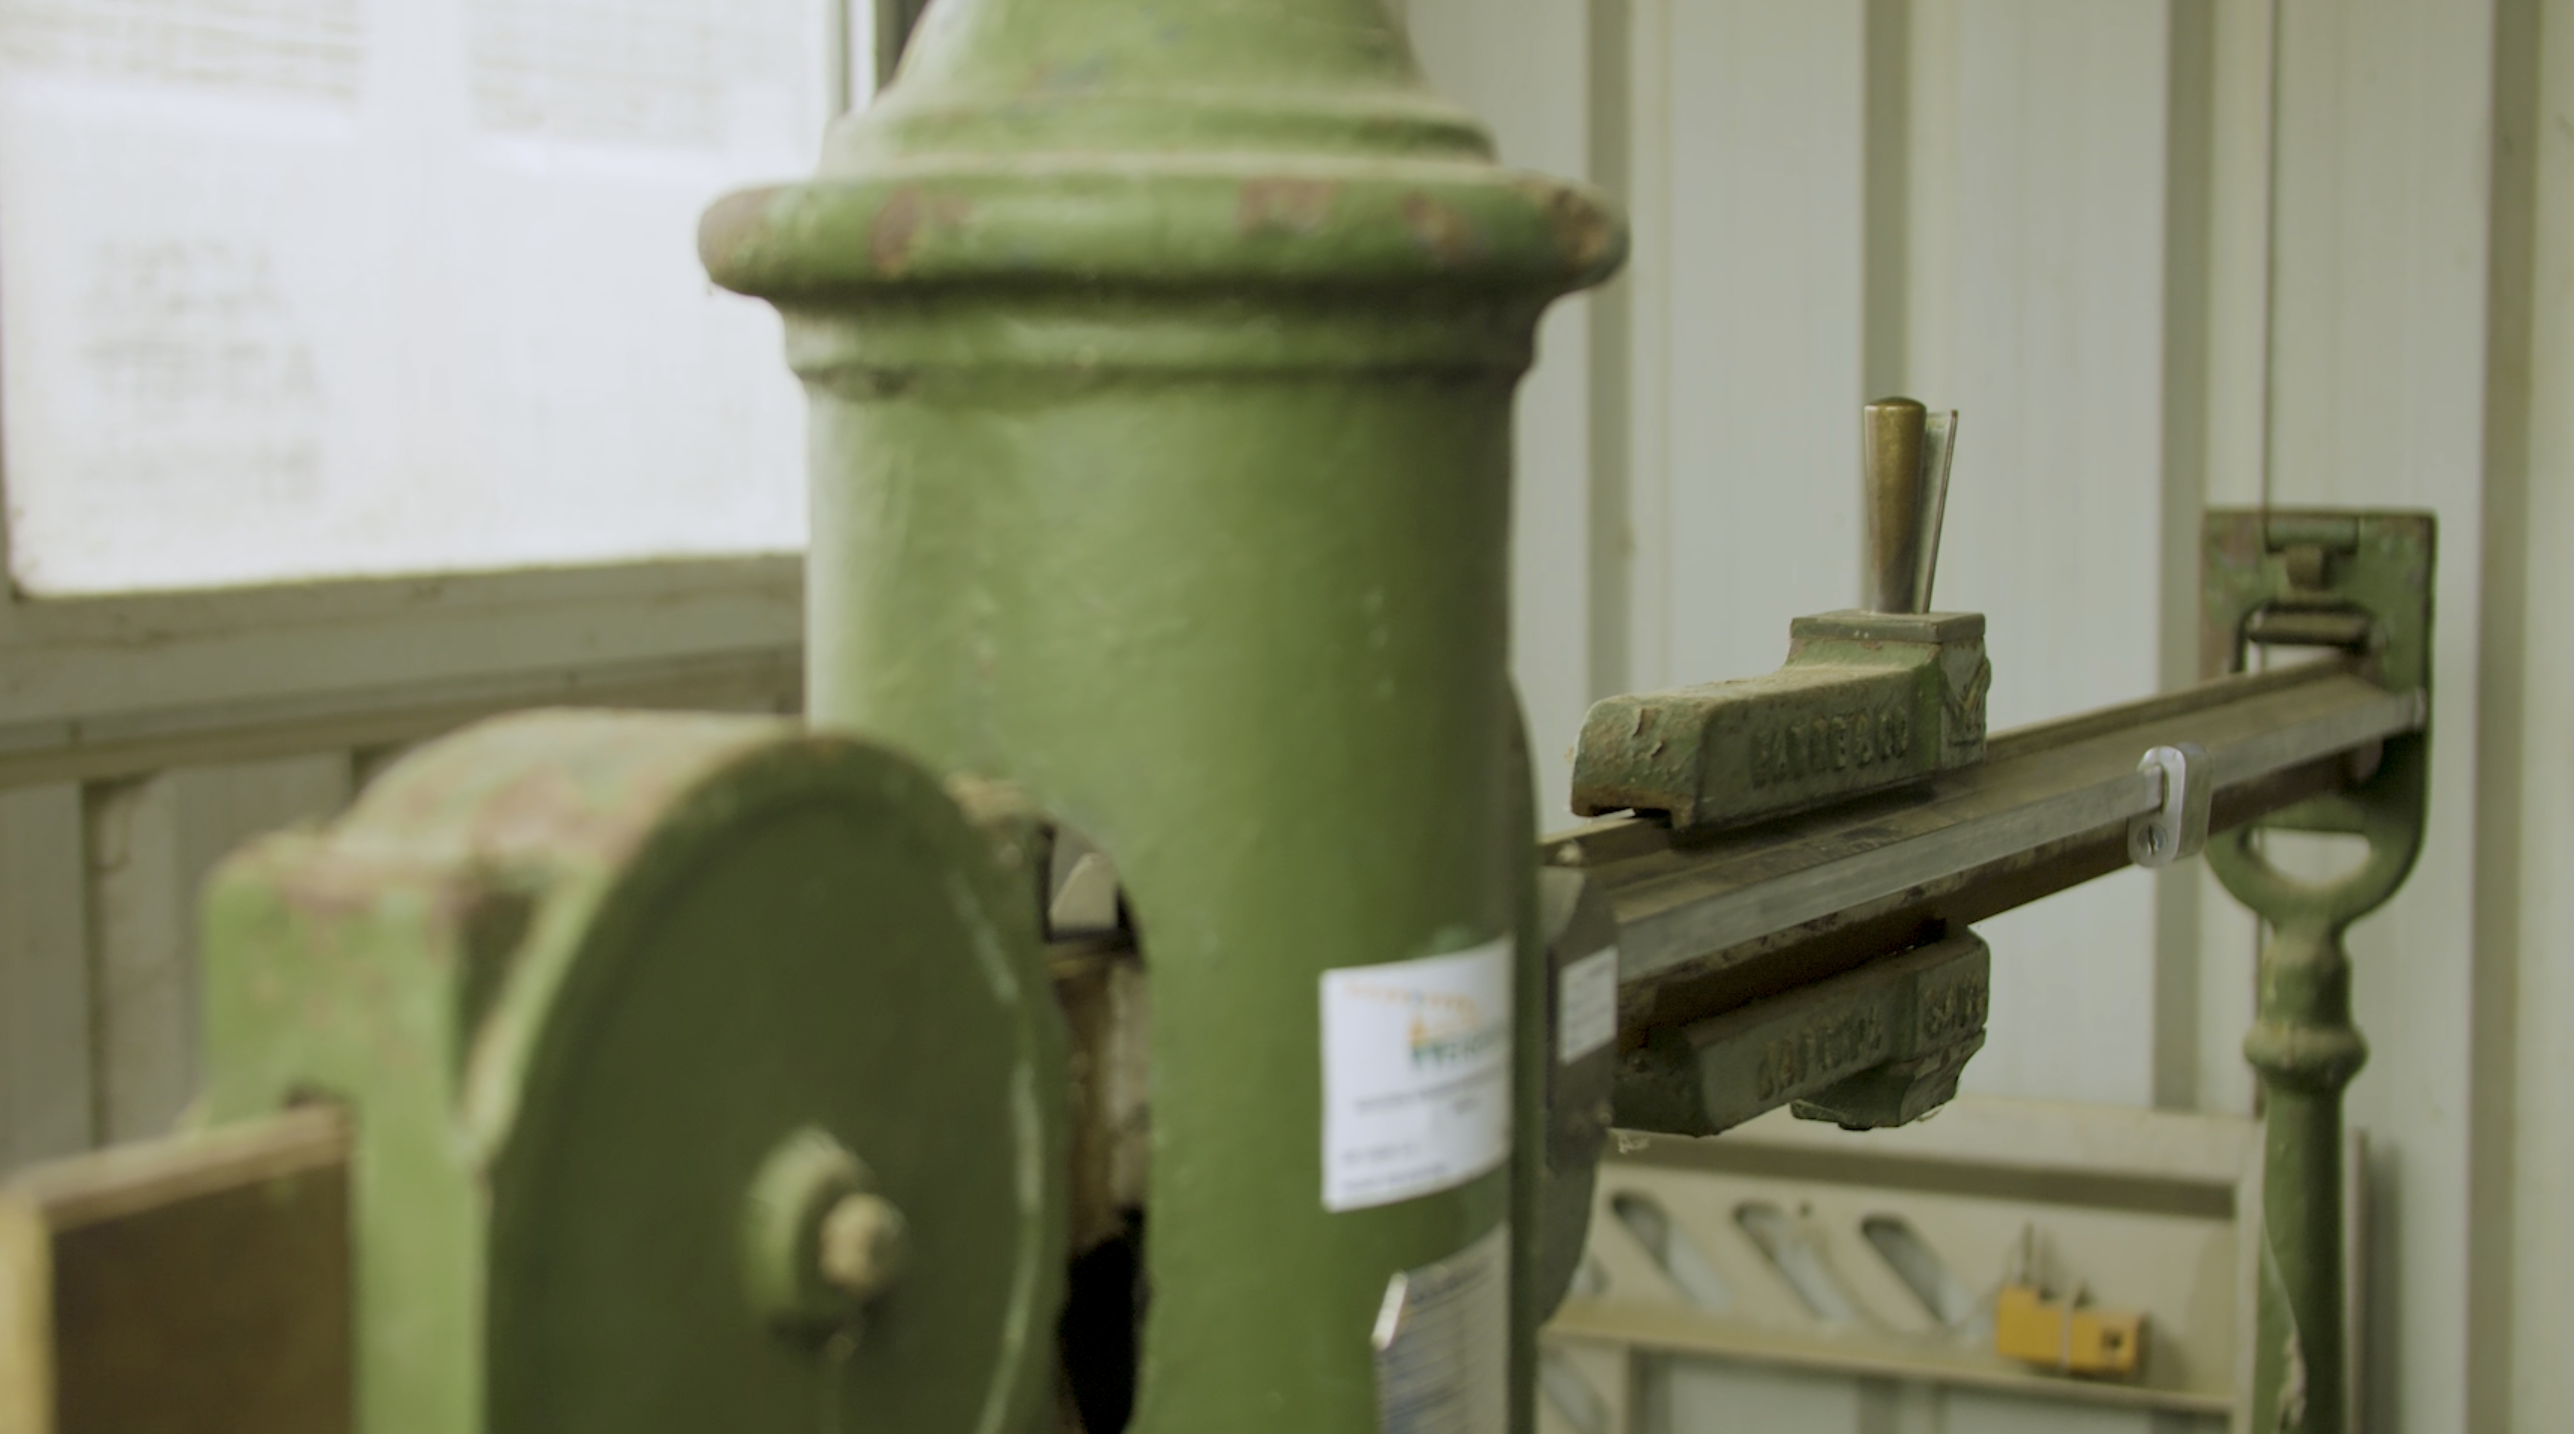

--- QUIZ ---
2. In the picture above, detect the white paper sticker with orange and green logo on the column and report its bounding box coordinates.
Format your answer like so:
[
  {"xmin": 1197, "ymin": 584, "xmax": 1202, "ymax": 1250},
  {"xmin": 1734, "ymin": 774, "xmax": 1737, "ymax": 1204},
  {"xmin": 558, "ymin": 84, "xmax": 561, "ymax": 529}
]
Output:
[{"xmin": 1323, "ymin": 937, "xmax": 1514, "ymax": 1210}]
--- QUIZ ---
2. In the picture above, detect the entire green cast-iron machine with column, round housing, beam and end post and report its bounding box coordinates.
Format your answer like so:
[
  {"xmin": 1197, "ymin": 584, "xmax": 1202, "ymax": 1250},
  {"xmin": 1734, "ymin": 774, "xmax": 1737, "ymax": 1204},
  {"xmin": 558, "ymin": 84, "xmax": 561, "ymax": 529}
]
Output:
[{"xmin": 0, "ymin": 0, "xmax": 2432, "ymax": 1434}]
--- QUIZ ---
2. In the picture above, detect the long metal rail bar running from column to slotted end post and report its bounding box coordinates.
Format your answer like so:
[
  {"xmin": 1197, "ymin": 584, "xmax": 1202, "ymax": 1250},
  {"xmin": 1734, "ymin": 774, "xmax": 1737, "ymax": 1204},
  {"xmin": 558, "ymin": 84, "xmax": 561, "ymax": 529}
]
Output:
[{"xmin": 1544, "ymin": 659, "xmax": 2425, "ymax": 1038}]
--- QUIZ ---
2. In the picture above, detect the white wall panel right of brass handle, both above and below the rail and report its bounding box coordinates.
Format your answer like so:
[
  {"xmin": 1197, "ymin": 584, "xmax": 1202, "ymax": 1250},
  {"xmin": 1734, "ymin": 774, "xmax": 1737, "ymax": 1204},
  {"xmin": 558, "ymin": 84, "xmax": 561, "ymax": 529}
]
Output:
[{"xmin": 1907, "ymin": 0, "xmax": 2170, "ymax": 1104}]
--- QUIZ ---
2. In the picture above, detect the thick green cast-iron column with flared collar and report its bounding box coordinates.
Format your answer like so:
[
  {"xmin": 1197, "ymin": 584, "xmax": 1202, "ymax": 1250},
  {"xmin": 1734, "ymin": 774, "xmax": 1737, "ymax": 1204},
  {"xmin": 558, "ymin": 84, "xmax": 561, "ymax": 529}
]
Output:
[{"xmin": 700, "ymin": 0, "xmax": 1624, "ymax": 1434}]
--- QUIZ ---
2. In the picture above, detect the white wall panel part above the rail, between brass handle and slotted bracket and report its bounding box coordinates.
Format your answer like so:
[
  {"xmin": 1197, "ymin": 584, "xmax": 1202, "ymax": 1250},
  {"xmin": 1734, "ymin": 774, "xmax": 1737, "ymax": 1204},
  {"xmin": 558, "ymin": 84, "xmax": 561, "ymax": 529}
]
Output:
[{"xmin": 1923, "ymin": 0, "xmax": 2165, "ymax": 726}]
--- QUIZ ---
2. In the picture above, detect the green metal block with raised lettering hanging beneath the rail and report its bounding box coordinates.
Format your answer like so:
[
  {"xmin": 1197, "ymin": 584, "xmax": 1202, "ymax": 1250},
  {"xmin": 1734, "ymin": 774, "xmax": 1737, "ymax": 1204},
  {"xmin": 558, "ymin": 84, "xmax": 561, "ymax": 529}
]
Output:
[{"xmin": 1616, "ymin": 932, "xmax": 1992, "ymax": 1135}]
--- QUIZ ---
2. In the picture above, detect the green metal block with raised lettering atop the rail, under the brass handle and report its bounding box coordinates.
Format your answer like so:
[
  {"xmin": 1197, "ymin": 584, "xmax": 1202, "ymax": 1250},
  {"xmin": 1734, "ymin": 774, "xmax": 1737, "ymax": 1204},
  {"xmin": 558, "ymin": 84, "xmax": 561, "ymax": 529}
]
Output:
[{"xmin": 1573, "ymin": 613, "xmax": 1992, "ymax": 832}]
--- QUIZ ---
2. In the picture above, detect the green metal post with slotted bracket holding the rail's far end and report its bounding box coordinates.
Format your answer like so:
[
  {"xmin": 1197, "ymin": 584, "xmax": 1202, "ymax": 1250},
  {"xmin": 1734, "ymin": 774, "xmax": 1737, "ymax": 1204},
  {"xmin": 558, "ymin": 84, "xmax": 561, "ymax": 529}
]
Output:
[{"xmin": 2201, "ymin": 510, "xmax": 2438, "ymax": 1434}]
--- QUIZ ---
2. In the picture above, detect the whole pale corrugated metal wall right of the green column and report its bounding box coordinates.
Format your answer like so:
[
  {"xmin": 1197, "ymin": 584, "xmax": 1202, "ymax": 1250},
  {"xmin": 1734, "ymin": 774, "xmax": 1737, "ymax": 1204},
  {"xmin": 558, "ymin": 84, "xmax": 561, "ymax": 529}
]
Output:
[{"xmin": 1408, "ymin": 0, "xmax": 2574, "ymax": 1434}]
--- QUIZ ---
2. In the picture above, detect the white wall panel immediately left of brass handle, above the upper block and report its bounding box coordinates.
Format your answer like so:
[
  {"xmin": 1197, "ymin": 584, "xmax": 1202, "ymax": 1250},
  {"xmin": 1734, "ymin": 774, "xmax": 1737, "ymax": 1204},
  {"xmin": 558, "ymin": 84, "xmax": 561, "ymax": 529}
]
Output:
[{"xmin": 1634, "ymin": 0, "xmax": 1864, "ymax": 685}]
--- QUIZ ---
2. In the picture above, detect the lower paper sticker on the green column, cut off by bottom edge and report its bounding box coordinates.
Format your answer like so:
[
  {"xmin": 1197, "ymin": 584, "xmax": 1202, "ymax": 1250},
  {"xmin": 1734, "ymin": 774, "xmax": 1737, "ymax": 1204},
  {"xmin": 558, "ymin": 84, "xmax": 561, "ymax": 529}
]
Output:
[{"xmin": 1372, "ymin": 1225, "xmax": 1511, "ymax": 1434}]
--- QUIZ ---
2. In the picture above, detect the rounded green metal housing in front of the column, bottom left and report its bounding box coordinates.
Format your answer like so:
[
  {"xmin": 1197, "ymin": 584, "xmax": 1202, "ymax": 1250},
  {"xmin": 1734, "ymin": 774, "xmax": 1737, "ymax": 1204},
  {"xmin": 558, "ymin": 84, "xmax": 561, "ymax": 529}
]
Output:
[{"xmin": 206, "ymin": 713, "xmax": 1066, "ymax": 1434}]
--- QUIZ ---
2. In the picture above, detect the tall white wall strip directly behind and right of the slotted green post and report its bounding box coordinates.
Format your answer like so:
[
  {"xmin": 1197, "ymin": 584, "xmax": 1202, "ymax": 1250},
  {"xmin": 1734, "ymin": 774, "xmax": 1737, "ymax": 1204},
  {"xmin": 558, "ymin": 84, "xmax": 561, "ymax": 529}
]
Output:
[{"xmin": 2270, "ymin": 0, "xmax": 2494, "ymax": 1434}]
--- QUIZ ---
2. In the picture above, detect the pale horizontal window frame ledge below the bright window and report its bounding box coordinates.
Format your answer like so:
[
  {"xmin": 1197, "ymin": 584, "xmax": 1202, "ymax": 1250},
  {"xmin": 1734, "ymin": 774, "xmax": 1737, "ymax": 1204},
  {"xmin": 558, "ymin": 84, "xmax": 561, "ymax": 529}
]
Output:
[{"xmin": 0, "ymin": 535, "xmax": 803, "ymax": 788}]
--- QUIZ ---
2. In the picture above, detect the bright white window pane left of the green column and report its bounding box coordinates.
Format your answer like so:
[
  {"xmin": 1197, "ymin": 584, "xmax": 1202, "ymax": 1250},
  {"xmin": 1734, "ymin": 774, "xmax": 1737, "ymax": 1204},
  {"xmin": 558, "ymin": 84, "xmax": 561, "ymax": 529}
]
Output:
[{"xmin": 0, "ymin": 0, "xmax": 834, "ymax": 595}]
